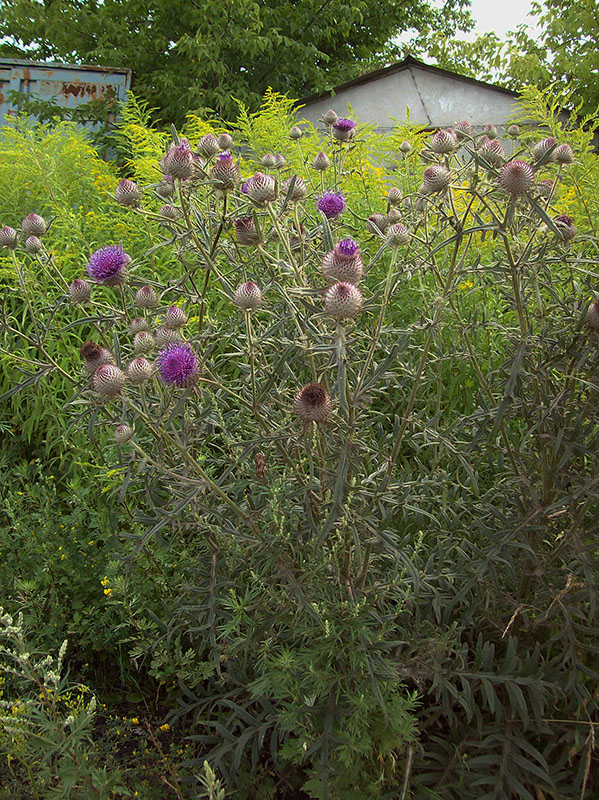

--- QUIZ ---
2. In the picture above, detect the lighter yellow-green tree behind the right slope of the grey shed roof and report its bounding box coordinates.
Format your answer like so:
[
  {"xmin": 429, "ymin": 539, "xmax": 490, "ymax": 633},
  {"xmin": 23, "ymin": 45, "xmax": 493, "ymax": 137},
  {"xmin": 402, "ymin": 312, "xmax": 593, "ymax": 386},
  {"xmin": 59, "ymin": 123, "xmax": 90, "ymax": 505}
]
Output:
[{"xmin": 420, "ymin": 0, "xmax": 599, "ymax": 114}]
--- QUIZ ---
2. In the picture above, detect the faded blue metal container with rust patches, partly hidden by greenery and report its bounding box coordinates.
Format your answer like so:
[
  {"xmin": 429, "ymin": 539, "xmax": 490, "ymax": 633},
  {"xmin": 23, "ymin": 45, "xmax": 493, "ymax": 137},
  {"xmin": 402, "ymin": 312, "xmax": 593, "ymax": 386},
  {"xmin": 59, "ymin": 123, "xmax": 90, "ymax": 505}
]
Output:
[{"xmin": 0, "ymin": 58, "xmax": 131, "ymax": 125}]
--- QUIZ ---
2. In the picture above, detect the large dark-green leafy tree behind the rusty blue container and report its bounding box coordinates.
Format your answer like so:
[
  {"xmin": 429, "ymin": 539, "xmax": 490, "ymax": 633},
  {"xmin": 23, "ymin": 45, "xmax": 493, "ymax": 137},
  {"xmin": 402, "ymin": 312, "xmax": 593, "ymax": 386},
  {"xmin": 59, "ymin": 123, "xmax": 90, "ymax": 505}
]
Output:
[{"xmin": 0, "ymin": 0, "xmax": 472, "ymax": 122}]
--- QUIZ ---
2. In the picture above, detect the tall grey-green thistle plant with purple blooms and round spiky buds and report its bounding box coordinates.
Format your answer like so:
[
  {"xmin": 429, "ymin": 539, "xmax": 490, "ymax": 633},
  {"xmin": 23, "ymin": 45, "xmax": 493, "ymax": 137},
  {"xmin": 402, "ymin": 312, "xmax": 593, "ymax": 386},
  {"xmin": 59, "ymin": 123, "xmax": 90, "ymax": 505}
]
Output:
[{"xmin": 0, "ymin": 113, "xmax": 599, "ymax": 798}]
